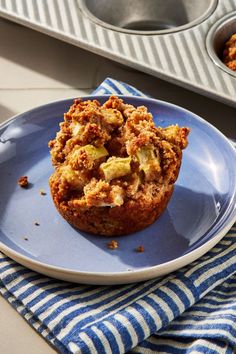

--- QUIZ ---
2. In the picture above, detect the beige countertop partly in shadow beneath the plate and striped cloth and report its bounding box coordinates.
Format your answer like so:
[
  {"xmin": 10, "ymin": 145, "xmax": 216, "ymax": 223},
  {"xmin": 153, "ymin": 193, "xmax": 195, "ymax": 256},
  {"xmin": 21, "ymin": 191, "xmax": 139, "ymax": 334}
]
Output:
[{"xmin": 0, "ymin": 19, "xmax": 236, "ymax": 354}]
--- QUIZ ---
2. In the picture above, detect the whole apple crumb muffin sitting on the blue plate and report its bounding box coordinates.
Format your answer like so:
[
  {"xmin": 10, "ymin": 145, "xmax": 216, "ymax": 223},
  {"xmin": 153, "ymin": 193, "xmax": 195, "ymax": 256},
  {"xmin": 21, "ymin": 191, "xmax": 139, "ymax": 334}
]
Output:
[{"xmin": 49, "ymin": 96, "xmax": 189, "ymax": 236}]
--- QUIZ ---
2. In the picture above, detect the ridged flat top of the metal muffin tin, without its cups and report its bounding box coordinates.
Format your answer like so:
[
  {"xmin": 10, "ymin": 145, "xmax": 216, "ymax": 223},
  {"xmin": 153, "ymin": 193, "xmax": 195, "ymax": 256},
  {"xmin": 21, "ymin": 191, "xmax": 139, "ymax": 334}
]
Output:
[{"xmin": 0, "ymin": 0, "xmax": 236, "ymax": 106}]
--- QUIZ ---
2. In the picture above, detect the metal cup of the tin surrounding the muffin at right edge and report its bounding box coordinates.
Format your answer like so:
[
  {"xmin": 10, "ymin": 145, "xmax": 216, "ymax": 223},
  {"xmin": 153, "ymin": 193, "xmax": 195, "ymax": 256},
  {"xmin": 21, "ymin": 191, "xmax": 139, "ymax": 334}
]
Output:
[{"xmin": 206, "ymin": 11, "xmax": 236, "ymax": 77}]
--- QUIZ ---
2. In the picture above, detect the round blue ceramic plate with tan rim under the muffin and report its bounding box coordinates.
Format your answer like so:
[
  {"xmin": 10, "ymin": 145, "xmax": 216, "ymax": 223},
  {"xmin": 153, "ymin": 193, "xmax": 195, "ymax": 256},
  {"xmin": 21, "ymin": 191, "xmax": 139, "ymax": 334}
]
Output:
[{"xmin": 0, "ymin": 96, "xmax": 236, "ymax": 284}]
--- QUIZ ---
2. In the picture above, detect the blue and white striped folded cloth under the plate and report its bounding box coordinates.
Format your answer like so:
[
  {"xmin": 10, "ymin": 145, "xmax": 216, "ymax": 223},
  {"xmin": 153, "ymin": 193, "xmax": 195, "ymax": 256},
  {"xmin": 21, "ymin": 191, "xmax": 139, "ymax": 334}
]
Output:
[{"xmin": 0, "ymin": 78, "xmax": 236, "ymax": 354}]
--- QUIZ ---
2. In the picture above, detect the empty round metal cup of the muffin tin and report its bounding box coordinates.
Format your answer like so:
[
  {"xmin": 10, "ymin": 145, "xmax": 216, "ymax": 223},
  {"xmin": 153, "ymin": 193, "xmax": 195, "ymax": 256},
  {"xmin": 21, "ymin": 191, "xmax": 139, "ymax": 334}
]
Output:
[{"xmin": 79, "ymin": 0, "xmax": 217, "ymax": 34}]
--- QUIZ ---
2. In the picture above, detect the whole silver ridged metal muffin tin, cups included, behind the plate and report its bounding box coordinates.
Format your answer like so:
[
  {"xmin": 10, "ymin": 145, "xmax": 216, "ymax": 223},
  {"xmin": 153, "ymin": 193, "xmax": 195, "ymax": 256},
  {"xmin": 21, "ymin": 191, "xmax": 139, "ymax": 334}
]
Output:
[{"xmin": 0, "ymin": 0, "xmax": 236, "ymax": 106}]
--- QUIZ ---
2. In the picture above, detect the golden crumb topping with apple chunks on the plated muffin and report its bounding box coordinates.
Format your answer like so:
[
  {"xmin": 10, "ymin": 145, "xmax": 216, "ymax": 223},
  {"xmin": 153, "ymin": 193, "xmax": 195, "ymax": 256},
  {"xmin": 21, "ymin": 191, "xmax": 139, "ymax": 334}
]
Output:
[{"xmin": 48, "ymin": 96, "xmax": 189, "ymax": 208}]
